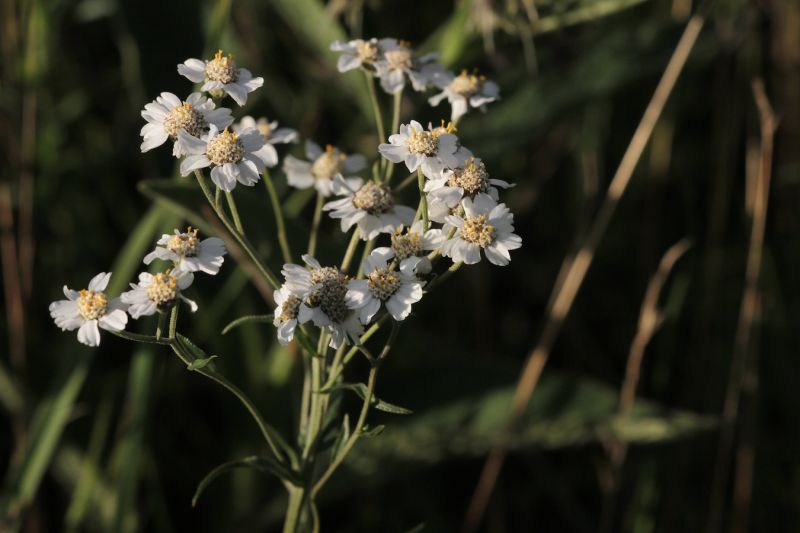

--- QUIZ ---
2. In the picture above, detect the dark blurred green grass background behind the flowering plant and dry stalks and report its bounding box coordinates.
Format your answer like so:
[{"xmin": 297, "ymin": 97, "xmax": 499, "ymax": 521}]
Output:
[{"xmin": 0, "ymin": 0, "xmax": 800, "ymax": 533}]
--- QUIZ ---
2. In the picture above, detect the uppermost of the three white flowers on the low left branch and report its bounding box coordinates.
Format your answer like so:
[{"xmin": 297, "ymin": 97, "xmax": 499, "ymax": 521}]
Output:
[{"xmin": 144, "ymin": 226, "xmax": 227, "ymax": 275}]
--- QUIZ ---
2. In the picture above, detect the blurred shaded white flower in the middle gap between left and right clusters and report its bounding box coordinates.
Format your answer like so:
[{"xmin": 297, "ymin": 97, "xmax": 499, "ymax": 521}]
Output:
[{"xmin": 283, "ymin": 141, "xmax": 367, "ymax": 198}]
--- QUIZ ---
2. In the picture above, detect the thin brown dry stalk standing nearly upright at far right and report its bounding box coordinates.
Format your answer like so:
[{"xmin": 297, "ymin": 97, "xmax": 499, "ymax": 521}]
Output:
[{"xmin": 706, "ymin": 79, "xmax": 778, "ymax": 532}]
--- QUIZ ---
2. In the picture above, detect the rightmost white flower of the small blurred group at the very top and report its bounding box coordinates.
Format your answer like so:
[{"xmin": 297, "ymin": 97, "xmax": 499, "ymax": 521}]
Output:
[{"xmin": 428, "ymin": 70, "xmax": 500, "ymax": 122}]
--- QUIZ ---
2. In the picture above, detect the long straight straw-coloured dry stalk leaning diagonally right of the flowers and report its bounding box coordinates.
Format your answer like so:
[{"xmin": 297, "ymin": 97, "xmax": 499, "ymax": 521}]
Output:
[{"xmin": 462, "ymin": 15, "xmax": 704, "ymax": 533}]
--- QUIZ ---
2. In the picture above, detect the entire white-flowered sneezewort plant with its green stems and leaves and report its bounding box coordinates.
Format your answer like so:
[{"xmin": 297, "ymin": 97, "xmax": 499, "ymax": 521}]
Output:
[{"xmin": 50, "ymin": 39, "xmax": 522, "ymax": 533}]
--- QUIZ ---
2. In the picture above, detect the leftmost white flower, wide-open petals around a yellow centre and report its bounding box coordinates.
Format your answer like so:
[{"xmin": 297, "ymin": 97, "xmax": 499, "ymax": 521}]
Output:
[{"xmin": 49, "ymin": 272, "xmax": 128, "ymax": 346}]
